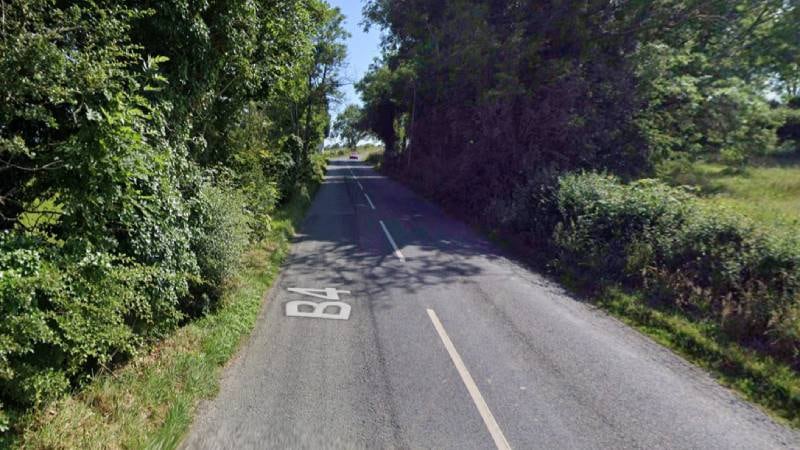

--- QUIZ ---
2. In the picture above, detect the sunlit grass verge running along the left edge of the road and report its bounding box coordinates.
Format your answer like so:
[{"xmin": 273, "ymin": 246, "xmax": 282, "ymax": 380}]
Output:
[{"xmin": 6, "ymin": 184, "xmax": 317, "ymax": 449}]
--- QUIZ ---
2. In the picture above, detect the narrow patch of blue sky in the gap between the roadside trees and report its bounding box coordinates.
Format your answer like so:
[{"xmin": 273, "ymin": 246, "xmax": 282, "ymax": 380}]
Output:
[{"xmin": 328, "ymin": 0, "xmax": 380, "ymax": 117}]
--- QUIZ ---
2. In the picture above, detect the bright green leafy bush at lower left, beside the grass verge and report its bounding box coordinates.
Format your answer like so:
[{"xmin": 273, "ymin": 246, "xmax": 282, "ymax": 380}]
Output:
[{"xmin": 0, "ymin": 233, "xmax": 175, "ymax": 406}]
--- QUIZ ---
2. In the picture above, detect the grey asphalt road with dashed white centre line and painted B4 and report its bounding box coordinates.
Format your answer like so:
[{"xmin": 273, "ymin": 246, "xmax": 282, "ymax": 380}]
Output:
[{"xmin": 183, "ymin": 160, "xmax": 800, "ymax": 449}]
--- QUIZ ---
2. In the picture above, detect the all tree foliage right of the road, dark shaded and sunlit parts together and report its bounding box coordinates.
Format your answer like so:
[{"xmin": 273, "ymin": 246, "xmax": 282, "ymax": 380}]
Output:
[{"xmin": 357, "ymin": 0, "xmax": 800, "ymax": 211}]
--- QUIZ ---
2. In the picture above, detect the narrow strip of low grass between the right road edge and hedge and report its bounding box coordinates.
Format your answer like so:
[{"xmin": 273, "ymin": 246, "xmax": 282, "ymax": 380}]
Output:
[{"xmin": 595, "ymin": 287, "xmax": 800, "ymax": 428}]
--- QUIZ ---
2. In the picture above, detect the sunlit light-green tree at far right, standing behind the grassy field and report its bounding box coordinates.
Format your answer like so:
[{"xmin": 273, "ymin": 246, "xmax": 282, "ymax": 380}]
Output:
[{"xmin": 630, "ymin": 0, "xmax": 800, "ymax": 166}]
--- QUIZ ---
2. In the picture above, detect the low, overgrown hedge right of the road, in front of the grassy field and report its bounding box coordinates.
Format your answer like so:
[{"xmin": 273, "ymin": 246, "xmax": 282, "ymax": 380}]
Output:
[{"xmin": 551, "ymin": 173, "xmax": 800, "ymax": 361}]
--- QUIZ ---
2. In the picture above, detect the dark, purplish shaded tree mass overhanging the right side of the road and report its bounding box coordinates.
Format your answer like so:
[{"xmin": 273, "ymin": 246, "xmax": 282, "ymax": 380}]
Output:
[{"xmin": 357, "ymin": 0, "xmax": 649, "ymax": 223}]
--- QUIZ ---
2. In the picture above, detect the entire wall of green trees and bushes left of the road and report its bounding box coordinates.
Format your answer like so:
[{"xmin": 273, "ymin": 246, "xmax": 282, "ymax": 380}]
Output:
[{"xmin": 0, "ymin": 0, "xmax": 346, "ymax": 428}]
